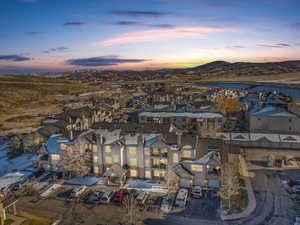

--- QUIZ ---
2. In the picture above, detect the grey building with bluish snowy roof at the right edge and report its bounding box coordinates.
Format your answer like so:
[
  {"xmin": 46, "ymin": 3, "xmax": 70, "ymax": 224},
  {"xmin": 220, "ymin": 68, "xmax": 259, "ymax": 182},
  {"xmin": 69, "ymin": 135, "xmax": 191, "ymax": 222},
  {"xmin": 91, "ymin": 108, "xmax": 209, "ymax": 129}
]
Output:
[{"xmin": 249, "ymin": 106, "xmax": 300, "ymax": 133}]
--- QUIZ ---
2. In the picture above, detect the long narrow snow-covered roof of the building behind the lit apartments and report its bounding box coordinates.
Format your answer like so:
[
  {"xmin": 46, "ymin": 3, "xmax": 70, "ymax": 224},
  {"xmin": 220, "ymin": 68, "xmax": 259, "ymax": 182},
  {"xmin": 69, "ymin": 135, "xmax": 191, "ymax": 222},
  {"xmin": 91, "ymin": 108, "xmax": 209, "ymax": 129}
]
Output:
[{"xmin": 139, "ymin": 112, "xmax": 223, "ymax": 119}]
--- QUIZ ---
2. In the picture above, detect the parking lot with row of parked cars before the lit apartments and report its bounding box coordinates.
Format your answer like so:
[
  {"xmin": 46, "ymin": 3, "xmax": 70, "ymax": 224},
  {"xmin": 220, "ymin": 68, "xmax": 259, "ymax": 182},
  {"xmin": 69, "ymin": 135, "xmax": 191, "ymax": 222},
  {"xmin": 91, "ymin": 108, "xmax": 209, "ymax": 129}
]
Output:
[{"xmin": 12, "ymin": 171, "xmax": 220, "ymax": 225}]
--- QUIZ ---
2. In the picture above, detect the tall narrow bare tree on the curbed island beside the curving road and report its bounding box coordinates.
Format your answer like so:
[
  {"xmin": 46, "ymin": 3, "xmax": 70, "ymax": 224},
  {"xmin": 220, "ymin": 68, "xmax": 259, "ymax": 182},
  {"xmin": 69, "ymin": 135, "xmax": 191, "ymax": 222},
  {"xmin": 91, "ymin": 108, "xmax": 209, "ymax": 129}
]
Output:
[{"xmin": 219, "ymin": 163, "xmax": 240, "ymax": 209}]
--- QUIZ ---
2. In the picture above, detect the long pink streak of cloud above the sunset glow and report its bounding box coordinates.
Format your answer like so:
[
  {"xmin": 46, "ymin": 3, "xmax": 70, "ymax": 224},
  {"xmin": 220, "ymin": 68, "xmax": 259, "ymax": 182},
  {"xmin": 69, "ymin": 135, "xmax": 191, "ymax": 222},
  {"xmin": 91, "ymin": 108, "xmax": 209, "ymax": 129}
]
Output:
[{"xmin": 93, "ymin": 26, "xmax": 236, "ymax": 46}]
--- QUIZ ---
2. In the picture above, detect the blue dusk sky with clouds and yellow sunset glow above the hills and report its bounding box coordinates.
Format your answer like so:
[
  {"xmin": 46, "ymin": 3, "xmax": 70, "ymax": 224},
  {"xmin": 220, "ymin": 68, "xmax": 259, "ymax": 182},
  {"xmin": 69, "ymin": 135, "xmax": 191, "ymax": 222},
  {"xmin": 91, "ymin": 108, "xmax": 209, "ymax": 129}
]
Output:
[{"xmin": 0, "ymin": 0, "xmax": 300, "ymax": 73}]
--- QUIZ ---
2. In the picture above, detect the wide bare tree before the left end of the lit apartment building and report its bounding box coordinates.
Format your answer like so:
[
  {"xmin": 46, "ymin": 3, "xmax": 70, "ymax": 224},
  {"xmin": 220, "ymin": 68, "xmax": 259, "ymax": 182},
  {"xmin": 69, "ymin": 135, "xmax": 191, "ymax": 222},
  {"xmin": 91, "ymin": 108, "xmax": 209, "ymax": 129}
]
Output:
[{"xmin": 60, "ymin": 147, "xmax": 92, "ymax": 176}]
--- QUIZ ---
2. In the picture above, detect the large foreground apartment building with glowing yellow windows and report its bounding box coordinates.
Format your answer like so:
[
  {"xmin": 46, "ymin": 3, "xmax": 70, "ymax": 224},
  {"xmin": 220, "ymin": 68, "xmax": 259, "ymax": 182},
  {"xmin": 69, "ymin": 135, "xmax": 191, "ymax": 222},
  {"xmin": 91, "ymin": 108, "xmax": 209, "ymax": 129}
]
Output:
[{"xmin": 46, "ymin": 124, "xmax": 221, "ymax": 187}]
